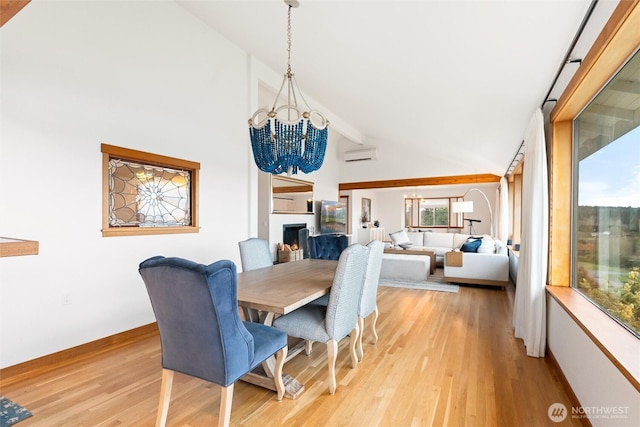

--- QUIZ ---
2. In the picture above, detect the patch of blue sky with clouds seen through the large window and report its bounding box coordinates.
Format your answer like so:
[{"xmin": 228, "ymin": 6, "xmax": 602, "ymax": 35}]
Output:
[{"xmin": 578, "ymin": 127, "xmax": 640, "ymax": 208}]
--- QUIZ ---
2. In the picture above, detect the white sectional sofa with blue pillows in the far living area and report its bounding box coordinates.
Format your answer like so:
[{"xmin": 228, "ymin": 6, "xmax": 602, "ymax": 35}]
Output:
[{"xmin": 389, "ymin": 230, "xmax": 509, "ymax": 288}]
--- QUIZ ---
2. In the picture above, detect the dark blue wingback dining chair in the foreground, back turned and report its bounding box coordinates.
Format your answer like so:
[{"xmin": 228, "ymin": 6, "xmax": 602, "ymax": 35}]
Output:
[{"xmin": 139, "ymin": 257, "xmax": 287, "ymax": 426}]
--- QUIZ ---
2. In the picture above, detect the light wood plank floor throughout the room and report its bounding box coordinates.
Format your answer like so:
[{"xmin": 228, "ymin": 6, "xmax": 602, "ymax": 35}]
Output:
[{"xmin": 1, "ymin": 280, "xmax": 580, "ymax": 427}]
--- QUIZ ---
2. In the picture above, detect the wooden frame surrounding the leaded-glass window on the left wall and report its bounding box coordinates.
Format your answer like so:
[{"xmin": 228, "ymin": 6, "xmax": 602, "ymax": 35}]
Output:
[{"xmin": 100, "ymin": 144, "xmax": 200, "ymax": 237}]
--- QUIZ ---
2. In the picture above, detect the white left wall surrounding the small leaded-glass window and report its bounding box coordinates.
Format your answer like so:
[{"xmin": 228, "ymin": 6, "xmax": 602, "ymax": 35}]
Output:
[{"xmin": 0, "ymin": 2, "xmax": 246, "ymax": 367}]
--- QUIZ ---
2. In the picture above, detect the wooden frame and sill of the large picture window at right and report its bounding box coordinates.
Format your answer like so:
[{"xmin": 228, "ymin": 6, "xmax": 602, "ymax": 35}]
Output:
[{"xmin": 547, "ymin": 0, "xmax": 640, "ymax": 391}]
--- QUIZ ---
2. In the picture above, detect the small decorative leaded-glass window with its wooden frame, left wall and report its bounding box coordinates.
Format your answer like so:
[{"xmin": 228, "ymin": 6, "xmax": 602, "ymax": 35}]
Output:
[{"xmin": 102, "ymin": 144, "xmax": 200, "ymax": 236}]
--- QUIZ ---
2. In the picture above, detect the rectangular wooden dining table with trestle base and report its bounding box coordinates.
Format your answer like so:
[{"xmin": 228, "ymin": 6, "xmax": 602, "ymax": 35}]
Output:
[{"xmin": 238, "ymin": 259, "xmax": 338, "ymax": 399}]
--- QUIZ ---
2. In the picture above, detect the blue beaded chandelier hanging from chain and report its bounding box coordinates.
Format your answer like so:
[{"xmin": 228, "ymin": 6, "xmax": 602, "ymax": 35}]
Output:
[{"xmin": 249, "ymin": 0, "xmax": 329, "ymax": 175}]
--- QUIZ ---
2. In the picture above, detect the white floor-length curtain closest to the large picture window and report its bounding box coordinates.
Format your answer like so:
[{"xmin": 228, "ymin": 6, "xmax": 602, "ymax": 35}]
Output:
[{"xmin": 513, "ymin": 108, "xmax": 549, "ymax": 357}]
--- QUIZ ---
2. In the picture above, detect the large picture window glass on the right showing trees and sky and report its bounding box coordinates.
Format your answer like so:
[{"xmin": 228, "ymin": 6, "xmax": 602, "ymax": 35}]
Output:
[{"xmin": 572, "ymin": 52, "xmax": 640, "ymax": 336}]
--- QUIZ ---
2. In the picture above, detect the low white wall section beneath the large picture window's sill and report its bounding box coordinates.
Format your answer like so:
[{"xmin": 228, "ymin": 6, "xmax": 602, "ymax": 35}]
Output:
[{"xmin": 547, "ymin": 296, "xmax": 640, "ymax": 427}]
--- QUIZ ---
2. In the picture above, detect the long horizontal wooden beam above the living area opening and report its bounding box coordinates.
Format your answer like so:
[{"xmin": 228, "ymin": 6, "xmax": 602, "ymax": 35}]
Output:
[{"xmin": 338, "ymin": 173, "xmax": 500, "ymax": 191}]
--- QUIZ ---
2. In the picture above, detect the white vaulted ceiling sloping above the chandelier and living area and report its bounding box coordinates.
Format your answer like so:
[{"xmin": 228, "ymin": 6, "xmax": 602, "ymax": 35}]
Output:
[{"xmin": 178, "ymin": 0, "xmax": 617, "ymax": 181}]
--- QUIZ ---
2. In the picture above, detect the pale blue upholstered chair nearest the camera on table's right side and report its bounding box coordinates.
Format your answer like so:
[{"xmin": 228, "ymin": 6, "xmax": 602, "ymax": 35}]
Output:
[{"xmin": 273, "ymin": 244, "xmax": 369, "ymax": 394}]
